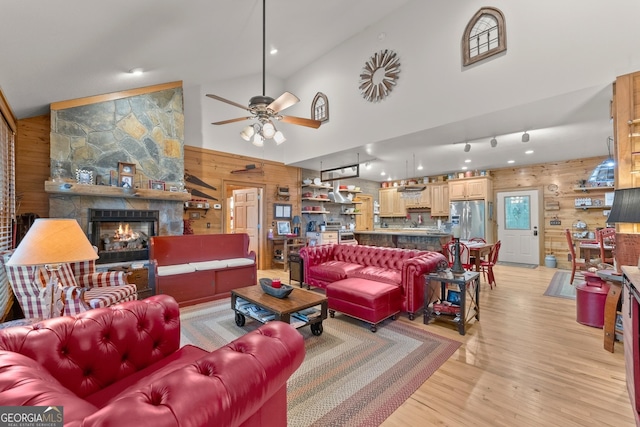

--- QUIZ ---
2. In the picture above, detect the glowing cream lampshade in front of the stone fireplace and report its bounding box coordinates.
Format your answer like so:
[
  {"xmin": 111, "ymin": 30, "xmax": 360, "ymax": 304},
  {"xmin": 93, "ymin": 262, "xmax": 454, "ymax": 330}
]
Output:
[{"xmin": 7, "ymin": 218, "xmax": 98, "ymax": 265}]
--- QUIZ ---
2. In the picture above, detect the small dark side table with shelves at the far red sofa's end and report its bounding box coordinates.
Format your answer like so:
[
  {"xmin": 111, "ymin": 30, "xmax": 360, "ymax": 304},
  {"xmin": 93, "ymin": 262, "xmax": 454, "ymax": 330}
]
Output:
[{"xmin": 423, "ymin": 271, "xmax": 480, "ymax": 335}]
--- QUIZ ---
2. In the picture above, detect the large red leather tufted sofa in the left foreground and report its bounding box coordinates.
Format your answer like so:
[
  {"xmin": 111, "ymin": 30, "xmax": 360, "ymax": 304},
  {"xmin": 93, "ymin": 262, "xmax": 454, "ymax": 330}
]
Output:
[{"xmin": 0, "ymin": 295, "xmax": 305, "ymax": 427}]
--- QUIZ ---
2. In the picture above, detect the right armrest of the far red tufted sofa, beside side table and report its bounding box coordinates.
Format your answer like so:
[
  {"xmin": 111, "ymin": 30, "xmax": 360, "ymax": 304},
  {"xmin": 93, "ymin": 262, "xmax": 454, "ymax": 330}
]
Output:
[{"xmin": 402, "ymin": 252, "xmax": 448, "ymax": 320}]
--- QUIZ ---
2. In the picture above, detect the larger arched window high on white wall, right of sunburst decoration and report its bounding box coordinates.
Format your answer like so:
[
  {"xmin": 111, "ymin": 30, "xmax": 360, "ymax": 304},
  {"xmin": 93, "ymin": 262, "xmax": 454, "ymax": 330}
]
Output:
[{"xmin": 462, "ymin": 7, "xmax": 507, "ymax": 66}]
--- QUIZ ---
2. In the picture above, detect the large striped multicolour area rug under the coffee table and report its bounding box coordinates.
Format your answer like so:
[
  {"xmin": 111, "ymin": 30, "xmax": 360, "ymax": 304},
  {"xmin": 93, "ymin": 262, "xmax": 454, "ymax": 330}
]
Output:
[{"xmin": 180, "ymin": 299, "xmax": 460, "ymax": 427}]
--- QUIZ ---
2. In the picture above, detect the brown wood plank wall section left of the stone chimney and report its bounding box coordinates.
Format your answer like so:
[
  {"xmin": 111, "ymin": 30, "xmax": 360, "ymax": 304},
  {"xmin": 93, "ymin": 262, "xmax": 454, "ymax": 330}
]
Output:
[{"xmin": 16, "ymin": 114, "xmax": 51, "ymax": 218}]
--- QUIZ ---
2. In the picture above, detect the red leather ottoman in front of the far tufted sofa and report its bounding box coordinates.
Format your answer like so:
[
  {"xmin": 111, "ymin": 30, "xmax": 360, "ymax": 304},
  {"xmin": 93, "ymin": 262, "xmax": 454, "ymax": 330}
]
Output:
[{"xmin": 326, "ymin": 278, "xmax": 402, "ymax": 332}]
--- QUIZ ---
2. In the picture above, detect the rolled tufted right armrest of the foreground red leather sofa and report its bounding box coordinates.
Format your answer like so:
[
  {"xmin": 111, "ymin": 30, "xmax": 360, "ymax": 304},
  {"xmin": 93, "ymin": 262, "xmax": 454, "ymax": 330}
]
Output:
[{"xmin": 69, "ymin": 321, "xmax": 305, "ymax": 427}]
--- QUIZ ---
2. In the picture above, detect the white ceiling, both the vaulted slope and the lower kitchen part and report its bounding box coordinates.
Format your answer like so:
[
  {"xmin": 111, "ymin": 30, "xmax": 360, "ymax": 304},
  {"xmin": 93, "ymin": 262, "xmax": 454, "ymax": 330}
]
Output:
[{"xmin": 0, "ymin": 0, "xmax": 640, "ymax": 181}]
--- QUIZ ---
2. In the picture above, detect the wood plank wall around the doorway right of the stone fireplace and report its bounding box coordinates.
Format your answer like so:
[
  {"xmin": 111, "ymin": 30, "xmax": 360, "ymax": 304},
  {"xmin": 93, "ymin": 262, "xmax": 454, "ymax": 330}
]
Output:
[{"xmin": 184, "ymin": 146, "xmax": 302, "ymax": 269}]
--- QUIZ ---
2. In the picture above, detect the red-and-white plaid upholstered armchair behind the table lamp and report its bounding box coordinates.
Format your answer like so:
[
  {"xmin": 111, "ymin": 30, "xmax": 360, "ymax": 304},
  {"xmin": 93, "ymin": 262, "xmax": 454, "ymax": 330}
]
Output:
[{"xmin": 3, "ymin": 252, "xmax": 138, "ymax": 319}]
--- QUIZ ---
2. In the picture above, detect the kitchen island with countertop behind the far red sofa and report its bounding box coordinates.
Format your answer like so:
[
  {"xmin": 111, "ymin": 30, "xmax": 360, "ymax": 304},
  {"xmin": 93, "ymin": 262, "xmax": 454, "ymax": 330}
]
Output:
[{"xmin": 354, "ymin": 232, "xmax": 453, "ymax": 252}]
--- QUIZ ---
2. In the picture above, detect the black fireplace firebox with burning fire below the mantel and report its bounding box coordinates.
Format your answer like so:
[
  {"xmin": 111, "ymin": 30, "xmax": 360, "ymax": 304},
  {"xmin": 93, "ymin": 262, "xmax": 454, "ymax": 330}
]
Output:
[{"xmin": 89, "ymin": 209, "xmax": 160, "ymax": 264}]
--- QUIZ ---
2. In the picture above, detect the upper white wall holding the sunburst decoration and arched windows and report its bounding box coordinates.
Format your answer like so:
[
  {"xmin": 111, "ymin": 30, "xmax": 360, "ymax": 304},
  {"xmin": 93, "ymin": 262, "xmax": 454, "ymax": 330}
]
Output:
[{"xmin": 185, "ymin": 0, "xmax": 640, "ymax": 163}]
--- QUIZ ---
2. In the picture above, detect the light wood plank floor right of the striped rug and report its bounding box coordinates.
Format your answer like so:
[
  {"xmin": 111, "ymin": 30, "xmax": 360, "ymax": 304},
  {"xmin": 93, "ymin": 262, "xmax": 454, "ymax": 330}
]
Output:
[{"xmin": 259, "ymin": 266, "xmax": 634, "ymax": 427}]
